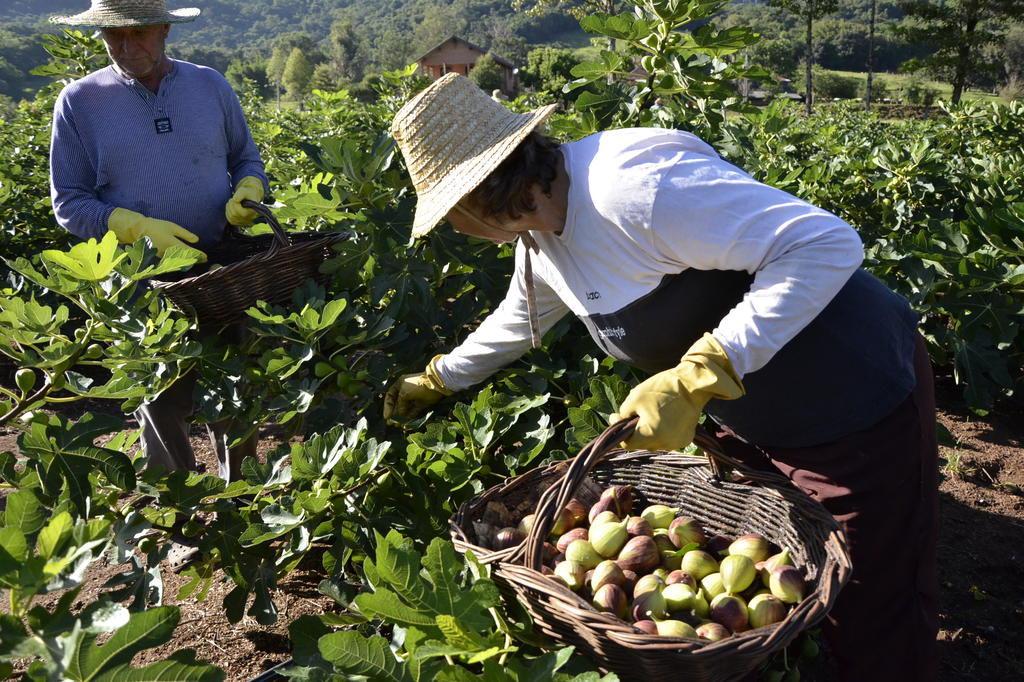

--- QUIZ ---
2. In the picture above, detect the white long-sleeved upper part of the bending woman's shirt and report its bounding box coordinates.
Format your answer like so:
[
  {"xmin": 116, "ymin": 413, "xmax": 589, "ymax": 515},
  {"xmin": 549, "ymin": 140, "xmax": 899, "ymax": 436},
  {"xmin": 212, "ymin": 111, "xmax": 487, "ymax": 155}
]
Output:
[{"xmin": 438, "ymin": 128, "xmax": 863, "ymax": 390}]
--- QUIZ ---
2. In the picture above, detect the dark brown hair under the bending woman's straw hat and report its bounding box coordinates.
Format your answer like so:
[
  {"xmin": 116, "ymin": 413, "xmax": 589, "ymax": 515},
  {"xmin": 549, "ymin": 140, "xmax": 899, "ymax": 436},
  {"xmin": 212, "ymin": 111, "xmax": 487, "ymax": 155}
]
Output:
[{"xmin": 469, "ymin": 132, "xmax": 559, "ymax": 219}]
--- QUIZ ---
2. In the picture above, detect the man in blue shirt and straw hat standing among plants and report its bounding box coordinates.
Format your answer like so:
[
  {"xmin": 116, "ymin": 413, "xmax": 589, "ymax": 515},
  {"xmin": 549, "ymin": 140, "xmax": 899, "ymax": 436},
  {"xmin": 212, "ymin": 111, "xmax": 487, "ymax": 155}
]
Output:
[{"xmin": 50, "ymin": 0, "xmax": 267, "ymax": 480}]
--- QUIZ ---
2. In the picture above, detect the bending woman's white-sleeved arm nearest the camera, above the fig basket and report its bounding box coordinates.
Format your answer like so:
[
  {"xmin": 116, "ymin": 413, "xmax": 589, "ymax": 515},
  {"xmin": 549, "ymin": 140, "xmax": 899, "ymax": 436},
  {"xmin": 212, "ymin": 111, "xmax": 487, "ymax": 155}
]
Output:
[{"xmin": 651, "ymin": 157, "xmax": 864, "ymax": 377}]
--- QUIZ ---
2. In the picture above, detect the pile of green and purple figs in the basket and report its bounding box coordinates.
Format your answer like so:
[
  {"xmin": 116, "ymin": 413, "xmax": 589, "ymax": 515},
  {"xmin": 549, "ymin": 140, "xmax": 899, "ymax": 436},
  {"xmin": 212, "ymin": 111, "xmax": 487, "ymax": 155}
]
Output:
[{"xmin": 495, "ymin": 485, "xmax": 806, "ymax": 641}]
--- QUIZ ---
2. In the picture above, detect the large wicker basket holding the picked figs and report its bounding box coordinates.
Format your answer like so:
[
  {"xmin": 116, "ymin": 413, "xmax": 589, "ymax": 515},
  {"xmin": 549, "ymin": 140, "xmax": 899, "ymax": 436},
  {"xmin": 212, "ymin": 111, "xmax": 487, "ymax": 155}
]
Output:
[{"xmin": 452, "ymin": 420, "xmax": 851, "ymax": 682}]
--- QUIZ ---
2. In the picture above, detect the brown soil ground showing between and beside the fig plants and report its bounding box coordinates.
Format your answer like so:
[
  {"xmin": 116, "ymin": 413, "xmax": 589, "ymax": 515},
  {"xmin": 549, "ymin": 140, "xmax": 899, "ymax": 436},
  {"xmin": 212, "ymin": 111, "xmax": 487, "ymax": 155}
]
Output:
[{"xmin": 0, "ymin": 378, "xmax": 1024, "ymax": 680}]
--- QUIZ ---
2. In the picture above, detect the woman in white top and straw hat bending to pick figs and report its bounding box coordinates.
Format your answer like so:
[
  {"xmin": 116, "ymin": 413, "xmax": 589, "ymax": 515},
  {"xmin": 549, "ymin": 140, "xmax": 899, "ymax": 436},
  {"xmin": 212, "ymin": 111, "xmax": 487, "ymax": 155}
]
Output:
[{"xmin": 385, "ymin": 75, "xmax": 937, "ymax": 680}]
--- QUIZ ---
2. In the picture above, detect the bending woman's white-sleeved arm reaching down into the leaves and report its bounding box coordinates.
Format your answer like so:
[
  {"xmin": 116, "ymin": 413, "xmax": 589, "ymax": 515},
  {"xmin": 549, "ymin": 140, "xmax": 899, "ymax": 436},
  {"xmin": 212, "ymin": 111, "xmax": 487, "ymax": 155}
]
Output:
[{"xmin": 436, "ymin": 242, "xmax": 568, "ymax": 391}]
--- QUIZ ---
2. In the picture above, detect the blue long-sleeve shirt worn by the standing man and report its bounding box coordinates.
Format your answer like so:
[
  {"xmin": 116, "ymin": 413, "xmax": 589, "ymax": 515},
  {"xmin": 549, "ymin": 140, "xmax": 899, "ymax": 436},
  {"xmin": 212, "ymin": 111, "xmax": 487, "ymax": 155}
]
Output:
[{"xmin": 50, "ymin": 59, "xmax": 266, "ymax": 248}]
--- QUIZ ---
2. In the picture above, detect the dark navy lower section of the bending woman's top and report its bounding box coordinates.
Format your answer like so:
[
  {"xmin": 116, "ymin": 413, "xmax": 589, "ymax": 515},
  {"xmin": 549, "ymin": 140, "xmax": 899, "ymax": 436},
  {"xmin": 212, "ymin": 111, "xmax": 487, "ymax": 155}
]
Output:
[{"xmin": 583, "ymin": 269, "xmax": 918, "ymax": 447}]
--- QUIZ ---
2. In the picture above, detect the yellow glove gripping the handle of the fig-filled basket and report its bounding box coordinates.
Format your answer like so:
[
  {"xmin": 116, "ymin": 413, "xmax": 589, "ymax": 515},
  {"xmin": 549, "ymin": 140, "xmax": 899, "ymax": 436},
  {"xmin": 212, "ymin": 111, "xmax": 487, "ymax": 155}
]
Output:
[{"xmin": 608, "ymin": 334, "xmax": 745, "ymax": 450}]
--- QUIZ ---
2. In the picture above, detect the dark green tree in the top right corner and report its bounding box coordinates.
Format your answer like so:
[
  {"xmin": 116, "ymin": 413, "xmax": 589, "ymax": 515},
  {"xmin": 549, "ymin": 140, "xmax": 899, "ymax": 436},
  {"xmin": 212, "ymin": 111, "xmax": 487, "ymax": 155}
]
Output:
[{"xmin": 894, "ymin": 0, "xmax": 1024, "ymax": 104}]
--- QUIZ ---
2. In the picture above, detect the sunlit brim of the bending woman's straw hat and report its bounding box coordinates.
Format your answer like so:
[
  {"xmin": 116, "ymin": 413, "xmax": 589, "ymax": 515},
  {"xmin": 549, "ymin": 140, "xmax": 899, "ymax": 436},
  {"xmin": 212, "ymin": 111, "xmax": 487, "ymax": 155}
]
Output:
[{"xmin": 413, "ymin": 100, "xmax": 558, "ymax": 238}]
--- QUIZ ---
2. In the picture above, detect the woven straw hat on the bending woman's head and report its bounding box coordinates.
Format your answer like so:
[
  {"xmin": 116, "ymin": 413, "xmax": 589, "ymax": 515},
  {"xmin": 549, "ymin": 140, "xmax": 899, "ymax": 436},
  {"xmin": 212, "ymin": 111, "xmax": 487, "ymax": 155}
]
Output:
[{"xmin": 391, "ymin": 74, "xmax": 558, "ymax": 237}]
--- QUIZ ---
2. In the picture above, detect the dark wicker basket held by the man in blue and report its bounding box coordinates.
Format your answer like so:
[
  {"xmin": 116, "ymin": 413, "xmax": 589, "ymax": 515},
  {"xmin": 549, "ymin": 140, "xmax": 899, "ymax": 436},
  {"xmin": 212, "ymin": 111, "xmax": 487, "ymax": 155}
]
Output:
[{"xmin": 152, "ymin": 201, "xmax": 348, "ymax": 327}]
